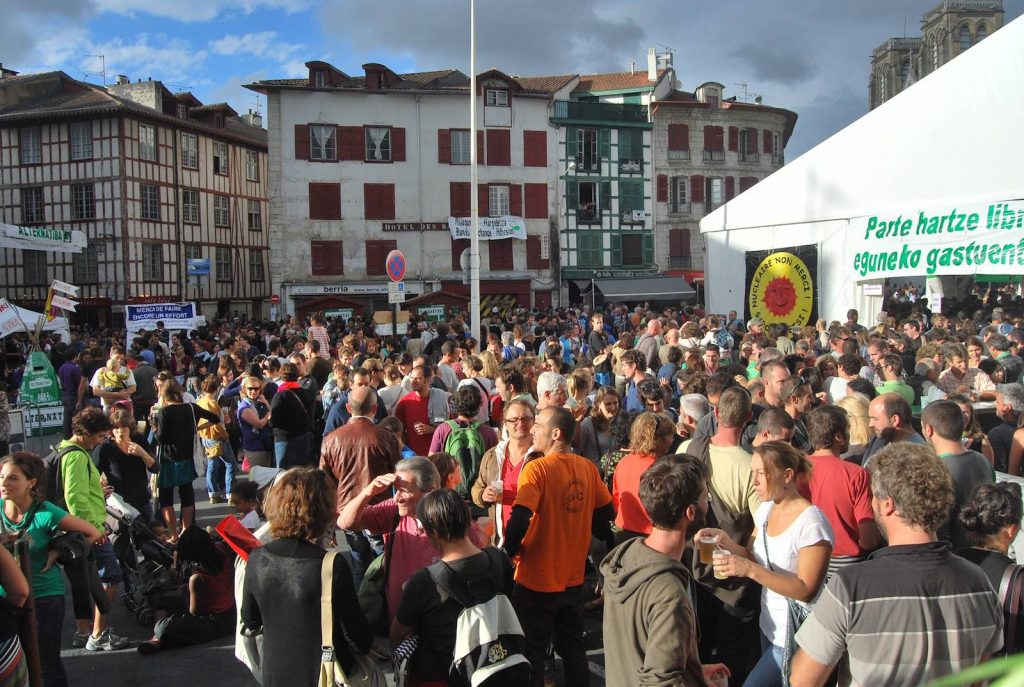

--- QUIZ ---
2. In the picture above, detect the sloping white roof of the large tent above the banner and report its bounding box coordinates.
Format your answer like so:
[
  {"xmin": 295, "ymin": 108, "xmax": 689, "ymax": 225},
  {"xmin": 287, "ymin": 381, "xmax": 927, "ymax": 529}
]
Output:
[{"xmin": 700, "ymin": 17, "xmax": 1024, "ymax": 233}]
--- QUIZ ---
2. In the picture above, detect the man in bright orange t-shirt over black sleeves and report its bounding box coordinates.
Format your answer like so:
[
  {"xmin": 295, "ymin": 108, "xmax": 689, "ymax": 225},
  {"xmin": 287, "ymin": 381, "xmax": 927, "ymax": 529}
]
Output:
[{"xmin": 505, "ymin": 406, "xmax": 615, "ymax": 687}]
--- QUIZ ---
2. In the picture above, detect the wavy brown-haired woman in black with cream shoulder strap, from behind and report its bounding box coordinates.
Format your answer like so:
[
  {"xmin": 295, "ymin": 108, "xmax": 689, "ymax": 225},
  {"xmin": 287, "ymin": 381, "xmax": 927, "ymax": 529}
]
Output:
[{"xmin": 242, "ymin": 467, "xmax": 372, "ymax": 687}]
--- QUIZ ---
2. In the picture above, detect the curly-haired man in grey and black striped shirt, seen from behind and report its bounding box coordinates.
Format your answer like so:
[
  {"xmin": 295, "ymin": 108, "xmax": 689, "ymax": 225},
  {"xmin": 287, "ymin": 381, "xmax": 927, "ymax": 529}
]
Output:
[{"xmin": 790, "ymin": 442, "xmax": 1002, "ymax": 687}]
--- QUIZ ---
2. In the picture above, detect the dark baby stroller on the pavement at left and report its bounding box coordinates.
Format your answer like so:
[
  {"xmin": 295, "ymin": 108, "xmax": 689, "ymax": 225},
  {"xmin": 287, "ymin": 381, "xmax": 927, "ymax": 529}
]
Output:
[{"xmin": 106, "ymin": 493, "xmax": 180, "ymax": 627}]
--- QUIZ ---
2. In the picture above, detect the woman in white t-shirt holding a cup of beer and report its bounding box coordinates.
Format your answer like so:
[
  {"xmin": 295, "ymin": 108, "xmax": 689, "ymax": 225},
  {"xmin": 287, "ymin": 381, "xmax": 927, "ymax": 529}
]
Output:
[{"xmin": 694, "ymin": 441, "xmax": 835, "ymax": 687}]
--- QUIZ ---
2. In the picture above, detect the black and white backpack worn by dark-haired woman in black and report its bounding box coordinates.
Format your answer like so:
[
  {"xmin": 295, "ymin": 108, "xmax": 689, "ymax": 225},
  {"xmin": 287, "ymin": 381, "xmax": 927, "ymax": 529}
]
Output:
[{"xmin": 427, "ymin": 547, "xmax": 529, "ymax": 687}]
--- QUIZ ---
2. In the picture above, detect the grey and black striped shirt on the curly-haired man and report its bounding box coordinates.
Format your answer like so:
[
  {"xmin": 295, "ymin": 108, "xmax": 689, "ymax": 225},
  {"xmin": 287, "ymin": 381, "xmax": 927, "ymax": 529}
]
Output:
[{"xmin": 797, "ymin": 542, "xmax": 1002, "ymax": 686}]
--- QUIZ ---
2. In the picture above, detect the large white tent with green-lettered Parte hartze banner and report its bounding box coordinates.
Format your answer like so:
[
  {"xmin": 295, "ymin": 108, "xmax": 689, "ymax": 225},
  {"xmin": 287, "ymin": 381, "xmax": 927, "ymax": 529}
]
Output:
[{"xmin": 700, "ymin": 17, "xmax": 1024, "ymax": 320}]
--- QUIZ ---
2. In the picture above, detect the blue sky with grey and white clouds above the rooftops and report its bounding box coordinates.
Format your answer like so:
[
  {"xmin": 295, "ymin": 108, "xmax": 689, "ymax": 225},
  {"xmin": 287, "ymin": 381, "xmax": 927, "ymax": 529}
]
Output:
[{"xmin": 0, "ymin": 0, "xmax": 1024, "ymax": 159}]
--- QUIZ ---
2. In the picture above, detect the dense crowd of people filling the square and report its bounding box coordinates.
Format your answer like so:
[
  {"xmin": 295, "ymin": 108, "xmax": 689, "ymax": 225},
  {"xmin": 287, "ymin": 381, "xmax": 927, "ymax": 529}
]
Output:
[{"xmin": 0, "ymin": 292, "xmax": 1024, "ymax": 687}]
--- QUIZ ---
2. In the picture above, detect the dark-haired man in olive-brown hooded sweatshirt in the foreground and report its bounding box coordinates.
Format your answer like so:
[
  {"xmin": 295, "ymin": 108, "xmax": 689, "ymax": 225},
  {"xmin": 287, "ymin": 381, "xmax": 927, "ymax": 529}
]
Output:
[{"xmin": 601, "ymin": 455, "xmax": 729, "ymax": 685}]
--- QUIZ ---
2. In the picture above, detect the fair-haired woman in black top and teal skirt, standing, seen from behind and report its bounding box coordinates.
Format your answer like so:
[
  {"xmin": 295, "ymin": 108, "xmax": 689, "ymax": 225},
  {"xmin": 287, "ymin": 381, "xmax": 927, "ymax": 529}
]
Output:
[{"xmin": 154, "ymin": 380, "xmax": 220, "ymax": 541}]
